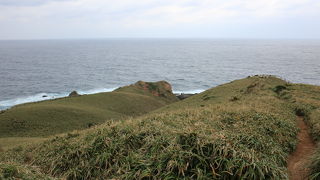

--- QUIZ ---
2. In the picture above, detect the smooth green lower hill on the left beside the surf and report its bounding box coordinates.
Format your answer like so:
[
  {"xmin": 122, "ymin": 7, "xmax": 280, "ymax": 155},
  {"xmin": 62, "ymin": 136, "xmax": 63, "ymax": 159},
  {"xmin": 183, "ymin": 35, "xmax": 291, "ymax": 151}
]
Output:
[{"xmin": 0, "ymin": 82, "xmax": 177, "ymax": 138}]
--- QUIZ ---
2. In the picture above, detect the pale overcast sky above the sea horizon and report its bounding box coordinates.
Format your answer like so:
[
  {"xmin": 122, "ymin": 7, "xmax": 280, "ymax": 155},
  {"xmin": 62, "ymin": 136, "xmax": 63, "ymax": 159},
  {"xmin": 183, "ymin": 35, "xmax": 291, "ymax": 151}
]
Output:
[{"xmin": 0, "ymin": 0, "xmax": 320, "ymax": 39}]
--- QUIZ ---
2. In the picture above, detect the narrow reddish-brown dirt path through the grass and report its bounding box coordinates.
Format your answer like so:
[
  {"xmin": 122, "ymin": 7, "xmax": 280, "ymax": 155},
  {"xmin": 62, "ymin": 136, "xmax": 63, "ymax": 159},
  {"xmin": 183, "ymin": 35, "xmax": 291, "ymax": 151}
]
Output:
[{"xmin": 288, "ymin": 117, "xmax": 316, "ymax": 180}]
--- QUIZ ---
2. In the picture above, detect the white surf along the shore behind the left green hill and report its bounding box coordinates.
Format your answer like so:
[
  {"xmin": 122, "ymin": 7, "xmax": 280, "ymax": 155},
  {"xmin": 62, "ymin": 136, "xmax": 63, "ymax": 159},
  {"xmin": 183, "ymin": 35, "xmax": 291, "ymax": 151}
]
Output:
[{"xmin": 0, "ymin": 88, "xmax": 116, "ymax": 110}]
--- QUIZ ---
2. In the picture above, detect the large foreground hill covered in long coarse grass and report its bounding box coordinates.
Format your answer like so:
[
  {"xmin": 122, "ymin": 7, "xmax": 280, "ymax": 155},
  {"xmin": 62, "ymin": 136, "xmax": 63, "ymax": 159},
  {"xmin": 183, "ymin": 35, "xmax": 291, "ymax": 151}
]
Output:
[{"xmin": 0, "ymin": 76, "xmax": 320, "ymax": 179}]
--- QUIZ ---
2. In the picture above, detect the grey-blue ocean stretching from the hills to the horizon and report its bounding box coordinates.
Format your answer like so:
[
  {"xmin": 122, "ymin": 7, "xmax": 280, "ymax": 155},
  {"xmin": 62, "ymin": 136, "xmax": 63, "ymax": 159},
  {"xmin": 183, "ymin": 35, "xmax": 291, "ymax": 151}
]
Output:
[{"xmin": 0, "ymin": 39, "xmax": 320, "ymax": 109}]
